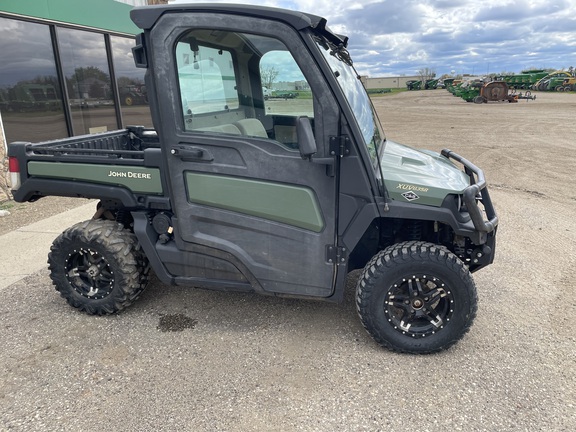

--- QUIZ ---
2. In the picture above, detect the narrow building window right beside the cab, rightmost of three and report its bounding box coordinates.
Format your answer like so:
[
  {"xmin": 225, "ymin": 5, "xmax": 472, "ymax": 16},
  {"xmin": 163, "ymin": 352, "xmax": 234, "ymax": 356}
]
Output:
[{"xmin": 110, "ymin": 36, "xmax": 152, "ymax": 127}]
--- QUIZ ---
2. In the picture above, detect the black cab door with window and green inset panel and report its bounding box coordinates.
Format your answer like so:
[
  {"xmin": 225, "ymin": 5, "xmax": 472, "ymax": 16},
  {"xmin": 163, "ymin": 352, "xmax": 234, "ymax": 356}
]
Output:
[{"xmin": 152, "ymin": 14, "xmax": 338, "ymax": 297}]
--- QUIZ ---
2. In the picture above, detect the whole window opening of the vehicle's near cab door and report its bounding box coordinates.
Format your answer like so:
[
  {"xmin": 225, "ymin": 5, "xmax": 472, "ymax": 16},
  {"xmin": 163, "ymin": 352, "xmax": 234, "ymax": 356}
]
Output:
[{"xmin": 174, "ymin": 29, "xmax": 314, "ymax": 150}]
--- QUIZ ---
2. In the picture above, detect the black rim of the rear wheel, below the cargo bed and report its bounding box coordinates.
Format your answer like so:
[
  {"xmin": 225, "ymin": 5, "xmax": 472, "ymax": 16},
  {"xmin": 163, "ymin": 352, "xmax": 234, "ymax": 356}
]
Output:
[{"xmin": 65, "ymin": 248, "xmax": 114, "ymax": 300}]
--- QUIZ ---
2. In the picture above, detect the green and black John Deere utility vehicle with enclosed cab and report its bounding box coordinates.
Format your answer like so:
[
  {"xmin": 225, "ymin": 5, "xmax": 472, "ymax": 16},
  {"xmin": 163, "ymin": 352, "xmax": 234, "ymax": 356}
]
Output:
[{"xmin": 9, "ymin": 4, "xmax": 498, "ymax": 353}]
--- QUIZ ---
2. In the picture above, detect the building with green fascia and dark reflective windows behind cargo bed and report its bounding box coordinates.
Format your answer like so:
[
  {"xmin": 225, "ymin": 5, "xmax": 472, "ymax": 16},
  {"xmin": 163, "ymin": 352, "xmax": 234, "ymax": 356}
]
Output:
[{"xmin": 0, "ymin": 0, "xmax": 152, "ymax": 142}]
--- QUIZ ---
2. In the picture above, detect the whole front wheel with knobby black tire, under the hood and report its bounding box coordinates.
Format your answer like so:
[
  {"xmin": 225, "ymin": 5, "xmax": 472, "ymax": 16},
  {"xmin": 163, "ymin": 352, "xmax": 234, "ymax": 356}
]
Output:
[{"xmin": 356, "ymin": 242, "xmax": 478, "ymax": 354}]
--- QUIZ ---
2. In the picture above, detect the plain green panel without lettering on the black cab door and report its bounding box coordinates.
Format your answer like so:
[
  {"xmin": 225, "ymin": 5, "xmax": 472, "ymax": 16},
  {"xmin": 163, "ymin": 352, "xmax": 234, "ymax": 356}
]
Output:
[{"xmin": 185, "ymin": 172, "xmax": 324, "ymax": 232}]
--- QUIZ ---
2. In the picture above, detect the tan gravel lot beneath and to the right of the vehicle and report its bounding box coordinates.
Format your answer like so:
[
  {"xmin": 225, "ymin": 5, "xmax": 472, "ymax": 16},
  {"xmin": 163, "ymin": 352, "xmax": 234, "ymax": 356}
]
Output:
[{"xmin": 0, "ymin": 90, "xmax": 576, "ymax": 432}]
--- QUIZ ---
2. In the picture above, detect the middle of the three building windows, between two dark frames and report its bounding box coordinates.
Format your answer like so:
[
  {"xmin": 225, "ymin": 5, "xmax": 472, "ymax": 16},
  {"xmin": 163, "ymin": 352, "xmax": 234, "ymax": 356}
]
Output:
[{"xmin": 58, "ymin": 28, "xmax": 118, "ymax": 135}]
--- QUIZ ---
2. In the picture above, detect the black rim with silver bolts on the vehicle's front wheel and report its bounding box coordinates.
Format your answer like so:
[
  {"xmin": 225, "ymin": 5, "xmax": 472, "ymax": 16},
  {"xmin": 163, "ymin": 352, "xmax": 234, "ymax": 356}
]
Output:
[{"xmin": 384, "ymin": 275, "xmax": 454, "ymax": 338}]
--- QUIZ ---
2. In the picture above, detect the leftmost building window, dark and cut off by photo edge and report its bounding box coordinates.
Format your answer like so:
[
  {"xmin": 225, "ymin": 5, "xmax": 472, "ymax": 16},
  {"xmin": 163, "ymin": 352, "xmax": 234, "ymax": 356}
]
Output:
[{"xmin": 0, "ymin": 18, "xmax": 68, "ymax": 142}]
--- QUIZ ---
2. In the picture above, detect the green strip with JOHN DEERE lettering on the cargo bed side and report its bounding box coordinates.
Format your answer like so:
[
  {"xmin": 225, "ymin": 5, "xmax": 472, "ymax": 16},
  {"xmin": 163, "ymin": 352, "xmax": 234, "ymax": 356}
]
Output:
[{"xmin": 28, "ymin": 161, "xmax": 162, "ymax": 195}]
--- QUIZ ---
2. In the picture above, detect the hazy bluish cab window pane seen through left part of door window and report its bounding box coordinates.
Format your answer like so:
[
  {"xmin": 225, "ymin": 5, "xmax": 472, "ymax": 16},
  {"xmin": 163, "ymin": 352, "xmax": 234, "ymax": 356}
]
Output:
[{"xmin": 176, "ymin": 39, "xmax": 238, "ymax": 129}]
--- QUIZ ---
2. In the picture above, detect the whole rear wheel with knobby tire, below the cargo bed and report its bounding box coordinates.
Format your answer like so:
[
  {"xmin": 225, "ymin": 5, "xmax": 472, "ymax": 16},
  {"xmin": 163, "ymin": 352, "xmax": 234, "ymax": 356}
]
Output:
[{"xmin": 48, "ymin": 220, "xmax": 150, "ymax": 315}]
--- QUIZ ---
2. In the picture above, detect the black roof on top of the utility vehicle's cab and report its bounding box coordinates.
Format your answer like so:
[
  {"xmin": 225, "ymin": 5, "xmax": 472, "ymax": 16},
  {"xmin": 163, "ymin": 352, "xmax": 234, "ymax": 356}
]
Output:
[{"xmin": 130, "ymin": 3, "xmax": 326, "ymax": 30}]
